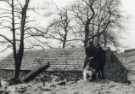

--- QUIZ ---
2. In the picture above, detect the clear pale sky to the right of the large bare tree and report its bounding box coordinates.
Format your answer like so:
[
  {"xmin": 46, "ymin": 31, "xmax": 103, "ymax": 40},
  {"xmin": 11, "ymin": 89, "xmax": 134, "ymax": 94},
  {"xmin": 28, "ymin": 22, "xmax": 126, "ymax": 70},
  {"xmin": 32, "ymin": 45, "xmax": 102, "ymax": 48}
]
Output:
[{"xmin": 122, "ymin": 0, "xmax": 135, "ymax": 48}]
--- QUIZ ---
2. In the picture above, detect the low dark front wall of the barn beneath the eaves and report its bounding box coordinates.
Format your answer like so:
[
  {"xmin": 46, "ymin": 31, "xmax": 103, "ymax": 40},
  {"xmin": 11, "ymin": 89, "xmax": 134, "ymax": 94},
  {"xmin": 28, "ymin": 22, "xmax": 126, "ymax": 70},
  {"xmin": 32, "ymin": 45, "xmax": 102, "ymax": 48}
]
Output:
[{"xmin": 0, "ymin": 69, "xmax": 82, "ymax": 81}]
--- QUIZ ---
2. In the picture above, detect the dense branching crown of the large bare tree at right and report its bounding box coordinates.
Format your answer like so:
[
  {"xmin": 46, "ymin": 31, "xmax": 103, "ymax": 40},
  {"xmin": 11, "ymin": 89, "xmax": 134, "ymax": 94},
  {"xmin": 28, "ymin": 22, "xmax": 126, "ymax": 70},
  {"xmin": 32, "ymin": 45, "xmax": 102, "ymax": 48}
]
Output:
[{"xmin": 72, "ymin": 0, "xmax": 121, "ymax": 48}]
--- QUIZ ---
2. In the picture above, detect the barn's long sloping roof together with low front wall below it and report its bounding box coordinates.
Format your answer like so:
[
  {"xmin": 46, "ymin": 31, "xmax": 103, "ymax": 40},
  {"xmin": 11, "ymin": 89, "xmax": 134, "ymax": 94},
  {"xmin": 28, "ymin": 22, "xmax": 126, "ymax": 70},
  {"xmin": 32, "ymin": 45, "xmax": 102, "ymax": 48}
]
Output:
[{"xmin": 0, "ymin": 48, "xmax": 85, "ymax": 79}]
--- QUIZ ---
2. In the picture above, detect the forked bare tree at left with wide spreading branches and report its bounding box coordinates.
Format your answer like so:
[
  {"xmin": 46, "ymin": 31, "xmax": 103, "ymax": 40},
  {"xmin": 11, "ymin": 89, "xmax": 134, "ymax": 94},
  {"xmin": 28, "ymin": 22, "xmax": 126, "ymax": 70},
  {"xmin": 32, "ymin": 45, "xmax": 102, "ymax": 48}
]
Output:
[{"xmin": 0, "ymin": 0, "xmax": 51, "ymax": 82}]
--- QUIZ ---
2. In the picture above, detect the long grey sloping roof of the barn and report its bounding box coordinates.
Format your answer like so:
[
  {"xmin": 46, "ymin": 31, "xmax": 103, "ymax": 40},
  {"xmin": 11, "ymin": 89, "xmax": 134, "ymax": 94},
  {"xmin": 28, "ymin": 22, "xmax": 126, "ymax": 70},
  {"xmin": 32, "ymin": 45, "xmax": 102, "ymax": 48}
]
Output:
[{"xmin": 0, "ymin": 48, "xmax": 85, "ymax": 70}]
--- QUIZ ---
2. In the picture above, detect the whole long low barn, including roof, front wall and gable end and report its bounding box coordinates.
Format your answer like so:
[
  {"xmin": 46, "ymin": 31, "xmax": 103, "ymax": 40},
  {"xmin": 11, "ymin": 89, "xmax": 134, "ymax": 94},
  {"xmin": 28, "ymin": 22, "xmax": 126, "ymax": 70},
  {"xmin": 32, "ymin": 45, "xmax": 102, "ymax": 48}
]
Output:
[{"xmin": 0, "ymin": 48, "xmax": 135, "ymax": 82}]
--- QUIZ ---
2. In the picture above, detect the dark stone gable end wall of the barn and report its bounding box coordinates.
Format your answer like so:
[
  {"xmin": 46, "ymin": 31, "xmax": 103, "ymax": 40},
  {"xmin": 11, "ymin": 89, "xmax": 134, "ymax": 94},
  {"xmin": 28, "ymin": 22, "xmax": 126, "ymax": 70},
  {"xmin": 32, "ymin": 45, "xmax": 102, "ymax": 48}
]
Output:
[{"xmin": 104, "ymin": 51, "xmax": 128, "ymax": 82}]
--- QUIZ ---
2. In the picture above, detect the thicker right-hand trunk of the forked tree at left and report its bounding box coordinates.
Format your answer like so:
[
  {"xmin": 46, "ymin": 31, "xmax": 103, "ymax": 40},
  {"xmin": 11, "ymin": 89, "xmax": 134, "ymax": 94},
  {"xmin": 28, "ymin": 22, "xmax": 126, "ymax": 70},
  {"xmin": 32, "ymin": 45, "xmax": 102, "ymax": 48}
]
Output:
[{"xmin": 14, "ymin": 0, "xmax": 29, "ymax": 80}]
